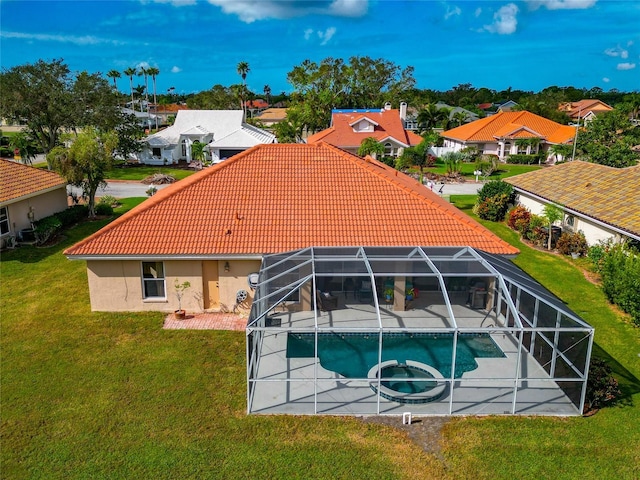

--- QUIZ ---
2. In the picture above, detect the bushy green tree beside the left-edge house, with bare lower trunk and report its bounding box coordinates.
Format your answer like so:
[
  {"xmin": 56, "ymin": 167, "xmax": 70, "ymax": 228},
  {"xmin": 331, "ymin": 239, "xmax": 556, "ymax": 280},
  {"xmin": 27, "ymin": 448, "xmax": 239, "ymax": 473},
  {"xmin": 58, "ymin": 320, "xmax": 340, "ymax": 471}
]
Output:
[{"xmin": 47, "ymin": 127, "xmax": 118, "ymax": 218}]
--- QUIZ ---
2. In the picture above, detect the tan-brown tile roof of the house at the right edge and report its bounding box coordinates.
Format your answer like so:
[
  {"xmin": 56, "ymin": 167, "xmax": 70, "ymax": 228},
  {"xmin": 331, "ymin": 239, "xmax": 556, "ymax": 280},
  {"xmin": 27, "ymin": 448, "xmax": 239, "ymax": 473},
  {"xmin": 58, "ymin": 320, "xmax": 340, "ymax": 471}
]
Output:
[{"xmin": 505, "ymin": 160, "xmax": 640, "ymax": 236}]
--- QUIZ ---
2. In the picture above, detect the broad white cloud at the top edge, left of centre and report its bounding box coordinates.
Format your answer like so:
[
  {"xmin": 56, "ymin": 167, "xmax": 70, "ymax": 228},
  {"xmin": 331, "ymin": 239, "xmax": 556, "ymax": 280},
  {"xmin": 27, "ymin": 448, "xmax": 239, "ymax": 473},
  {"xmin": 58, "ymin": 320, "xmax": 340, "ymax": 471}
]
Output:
[{"xmin": 202, "ymin": 0, "xmax": 369, "ymax": 23}]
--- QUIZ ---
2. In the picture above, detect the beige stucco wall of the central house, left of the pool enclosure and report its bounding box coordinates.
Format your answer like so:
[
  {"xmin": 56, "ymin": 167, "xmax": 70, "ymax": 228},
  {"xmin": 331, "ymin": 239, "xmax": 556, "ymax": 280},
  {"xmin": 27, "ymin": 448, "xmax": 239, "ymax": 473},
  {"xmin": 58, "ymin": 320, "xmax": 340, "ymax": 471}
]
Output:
[{"xmin": 87, "ymin": 260, "xmax": 260, "ymax": 313}]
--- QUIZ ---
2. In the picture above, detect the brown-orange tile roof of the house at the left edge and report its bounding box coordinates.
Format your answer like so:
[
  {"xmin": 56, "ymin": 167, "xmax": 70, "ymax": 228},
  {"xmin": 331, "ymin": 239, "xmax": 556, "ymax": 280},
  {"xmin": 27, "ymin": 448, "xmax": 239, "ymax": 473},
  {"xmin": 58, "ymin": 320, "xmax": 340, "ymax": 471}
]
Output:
[{"xmin": 0, "ymin": 160, "xmax": 67, "ymax": 203}]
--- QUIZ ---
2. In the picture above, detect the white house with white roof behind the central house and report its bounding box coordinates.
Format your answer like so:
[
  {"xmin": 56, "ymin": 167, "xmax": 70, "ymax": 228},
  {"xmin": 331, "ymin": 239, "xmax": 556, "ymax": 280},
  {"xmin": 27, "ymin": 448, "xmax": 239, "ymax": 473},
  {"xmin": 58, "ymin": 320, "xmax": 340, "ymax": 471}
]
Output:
[{"xmin": 138, "ymin": 110, "xmax": 276, "ymax": 165}]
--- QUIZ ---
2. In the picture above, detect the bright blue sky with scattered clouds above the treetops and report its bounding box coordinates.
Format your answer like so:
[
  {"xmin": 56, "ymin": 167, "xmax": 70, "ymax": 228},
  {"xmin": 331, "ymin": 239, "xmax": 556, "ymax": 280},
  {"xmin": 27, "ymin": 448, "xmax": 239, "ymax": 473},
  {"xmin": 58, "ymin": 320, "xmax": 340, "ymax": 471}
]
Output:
[{"xmin": 0, "ymin": 0, "xmax": 640, "ymax": 93}]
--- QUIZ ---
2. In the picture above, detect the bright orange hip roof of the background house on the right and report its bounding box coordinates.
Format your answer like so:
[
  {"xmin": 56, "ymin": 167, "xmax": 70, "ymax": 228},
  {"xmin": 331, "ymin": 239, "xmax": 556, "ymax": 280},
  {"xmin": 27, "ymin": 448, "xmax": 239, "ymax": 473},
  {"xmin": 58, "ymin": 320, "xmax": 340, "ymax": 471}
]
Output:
[{"xmin": 440, "ymin": 111, "xmax": 576, "ymax": 143}]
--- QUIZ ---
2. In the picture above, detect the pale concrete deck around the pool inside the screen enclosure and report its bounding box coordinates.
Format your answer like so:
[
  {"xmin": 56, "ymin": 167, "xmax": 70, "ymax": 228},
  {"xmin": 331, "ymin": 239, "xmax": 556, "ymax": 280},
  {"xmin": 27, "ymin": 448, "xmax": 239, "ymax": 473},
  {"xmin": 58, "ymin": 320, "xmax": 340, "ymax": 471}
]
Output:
[{"xmin": 249, "ymin": 294, "xmax": 579, "ymax": 416}]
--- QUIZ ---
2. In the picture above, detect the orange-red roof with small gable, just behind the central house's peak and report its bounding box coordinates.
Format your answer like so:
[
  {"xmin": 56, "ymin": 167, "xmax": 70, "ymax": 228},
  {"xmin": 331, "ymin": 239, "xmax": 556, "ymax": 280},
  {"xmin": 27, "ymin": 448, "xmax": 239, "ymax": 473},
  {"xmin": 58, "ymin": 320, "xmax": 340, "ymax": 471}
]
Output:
[{"xmin": 307, "ymin": 109, "xmax": 422, "ymax": 148}]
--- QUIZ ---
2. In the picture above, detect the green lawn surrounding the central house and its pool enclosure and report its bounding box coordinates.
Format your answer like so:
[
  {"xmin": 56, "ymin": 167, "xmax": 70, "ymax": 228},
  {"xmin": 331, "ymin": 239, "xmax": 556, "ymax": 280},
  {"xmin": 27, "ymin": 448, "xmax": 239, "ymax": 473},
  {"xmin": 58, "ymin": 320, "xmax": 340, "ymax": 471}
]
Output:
[{"xmin": 0, "ymin": 196, "xmax": 640, "ymax": 480}]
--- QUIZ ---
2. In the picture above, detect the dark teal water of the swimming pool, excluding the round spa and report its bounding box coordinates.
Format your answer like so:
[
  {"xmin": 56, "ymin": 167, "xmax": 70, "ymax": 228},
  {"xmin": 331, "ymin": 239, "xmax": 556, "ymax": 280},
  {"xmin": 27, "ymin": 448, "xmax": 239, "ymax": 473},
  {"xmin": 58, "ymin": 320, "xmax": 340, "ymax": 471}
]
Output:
[{"xmin": 287, "ymin": 332, "xmax": 505, "ymax": 378}]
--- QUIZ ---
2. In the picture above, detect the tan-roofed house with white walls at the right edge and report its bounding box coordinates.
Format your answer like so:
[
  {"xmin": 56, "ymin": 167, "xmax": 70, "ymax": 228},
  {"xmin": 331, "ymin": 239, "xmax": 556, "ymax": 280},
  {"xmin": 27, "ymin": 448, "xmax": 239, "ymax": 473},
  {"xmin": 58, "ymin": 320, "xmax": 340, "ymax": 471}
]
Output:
[{"xmin": 505, "ymin": 160, "xmax": 640, "ymax": 245}]
